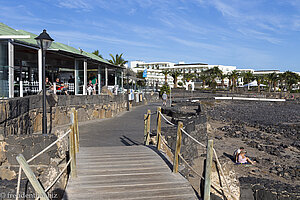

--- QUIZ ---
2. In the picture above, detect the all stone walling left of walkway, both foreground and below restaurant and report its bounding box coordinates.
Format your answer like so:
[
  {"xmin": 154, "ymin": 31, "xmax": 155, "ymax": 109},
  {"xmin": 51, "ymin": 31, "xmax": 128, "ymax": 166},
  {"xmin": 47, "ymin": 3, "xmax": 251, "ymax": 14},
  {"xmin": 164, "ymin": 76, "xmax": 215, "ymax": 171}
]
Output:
[{"xmin": 0, "ymin": 93, "xmax": 158, "ymax": 199}]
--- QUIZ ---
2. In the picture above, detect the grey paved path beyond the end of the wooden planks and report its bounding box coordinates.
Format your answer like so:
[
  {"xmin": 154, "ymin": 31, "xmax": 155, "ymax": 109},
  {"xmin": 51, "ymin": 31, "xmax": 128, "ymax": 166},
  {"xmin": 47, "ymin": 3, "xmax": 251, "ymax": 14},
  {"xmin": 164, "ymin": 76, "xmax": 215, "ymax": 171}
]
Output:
[{"xmin": 79, "ymin": 103, "xmax": 161, "ymax": 147}]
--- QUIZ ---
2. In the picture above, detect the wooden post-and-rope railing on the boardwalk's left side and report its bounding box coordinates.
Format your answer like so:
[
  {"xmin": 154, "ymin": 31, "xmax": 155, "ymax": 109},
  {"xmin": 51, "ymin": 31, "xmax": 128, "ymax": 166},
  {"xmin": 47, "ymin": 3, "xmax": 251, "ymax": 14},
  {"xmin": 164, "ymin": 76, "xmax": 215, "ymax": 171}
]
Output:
[{"xmin": 16, "ymin": 108, "xmax": 79, "ymax": 200}]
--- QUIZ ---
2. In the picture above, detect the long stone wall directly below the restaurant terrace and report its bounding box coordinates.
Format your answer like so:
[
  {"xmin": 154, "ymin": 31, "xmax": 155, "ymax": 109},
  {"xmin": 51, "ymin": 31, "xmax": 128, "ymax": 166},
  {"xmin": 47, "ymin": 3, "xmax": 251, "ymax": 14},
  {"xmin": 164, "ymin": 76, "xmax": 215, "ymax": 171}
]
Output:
[{"xmin": 0, "ymin": 93, "xmax": 158, "ymax": 137}]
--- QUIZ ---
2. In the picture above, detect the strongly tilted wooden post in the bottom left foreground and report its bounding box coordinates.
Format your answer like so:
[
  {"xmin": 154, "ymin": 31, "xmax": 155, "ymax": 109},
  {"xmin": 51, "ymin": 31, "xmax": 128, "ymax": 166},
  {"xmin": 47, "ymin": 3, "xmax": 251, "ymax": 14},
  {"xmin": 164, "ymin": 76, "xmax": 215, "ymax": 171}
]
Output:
[{"xmin": 17, "ymin": 154, "xmax": 49, "ymax": 200}]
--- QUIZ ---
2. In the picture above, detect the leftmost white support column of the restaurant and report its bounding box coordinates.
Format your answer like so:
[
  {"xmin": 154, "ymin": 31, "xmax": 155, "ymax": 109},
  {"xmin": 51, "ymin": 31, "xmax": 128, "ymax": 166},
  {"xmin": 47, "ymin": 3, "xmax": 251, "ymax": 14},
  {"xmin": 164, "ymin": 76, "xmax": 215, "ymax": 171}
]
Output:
[{"xmin": 8, "ymin": 41, "xmax": 14, "ymax": 98}]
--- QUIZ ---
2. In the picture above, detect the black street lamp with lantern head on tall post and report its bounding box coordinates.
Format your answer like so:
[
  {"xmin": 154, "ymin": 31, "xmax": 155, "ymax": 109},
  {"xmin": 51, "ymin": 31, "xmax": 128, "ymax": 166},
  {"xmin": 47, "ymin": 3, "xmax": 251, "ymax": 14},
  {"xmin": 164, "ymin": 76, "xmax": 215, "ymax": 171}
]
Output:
[{"xmin": 34, "ymin": 29, "xmax": 54, "ymax": 134}]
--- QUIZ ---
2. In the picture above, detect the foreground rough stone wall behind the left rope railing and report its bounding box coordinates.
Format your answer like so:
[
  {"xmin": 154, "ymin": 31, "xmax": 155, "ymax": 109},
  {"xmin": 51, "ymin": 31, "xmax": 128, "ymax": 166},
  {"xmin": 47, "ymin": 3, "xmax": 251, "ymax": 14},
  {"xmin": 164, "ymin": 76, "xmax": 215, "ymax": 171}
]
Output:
[{"xmin": 0, "ymin": 129, "xmax": 68, "ymax": 199}]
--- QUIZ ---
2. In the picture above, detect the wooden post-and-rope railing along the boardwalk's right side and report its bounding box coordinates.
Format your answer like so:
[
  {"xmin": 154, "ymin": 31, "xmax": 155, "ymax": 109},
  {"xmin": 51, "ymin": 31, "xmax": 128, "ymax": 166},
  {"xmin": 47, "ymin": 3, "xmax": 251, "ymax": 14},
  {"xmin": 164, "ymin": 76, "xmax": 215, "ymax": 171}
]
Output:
[{"xmin": 144, "ymin": 107, "xmax": 239, "ymax": 200}]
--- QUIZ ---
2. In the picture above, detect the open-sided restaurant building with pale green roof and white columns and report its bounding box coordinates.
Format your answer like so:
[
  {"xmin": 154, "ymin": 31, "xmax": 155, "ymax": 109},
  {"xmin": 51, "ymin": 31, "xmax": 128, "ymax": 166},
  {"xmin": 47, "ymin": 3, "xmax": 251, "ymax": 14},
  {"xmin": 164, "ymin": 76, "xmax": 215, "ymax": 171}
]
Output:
[{"xmin": 0, "ymin": 23, "xmax": 124, "ymax": 98}]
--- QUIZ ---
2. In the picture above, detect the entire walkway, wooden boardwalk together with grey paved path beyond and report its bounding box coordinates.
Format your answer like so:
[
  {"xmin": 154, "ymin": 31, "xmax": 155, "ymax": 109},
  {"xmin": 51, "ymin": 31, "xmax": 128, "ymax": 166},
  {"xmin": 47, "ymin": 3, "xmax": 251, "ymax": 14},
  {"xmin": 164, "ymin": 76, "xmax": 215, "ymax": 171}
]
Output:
[{"xmin": 64, "ymin": 104, "xmax": 197, "ymax": 200}]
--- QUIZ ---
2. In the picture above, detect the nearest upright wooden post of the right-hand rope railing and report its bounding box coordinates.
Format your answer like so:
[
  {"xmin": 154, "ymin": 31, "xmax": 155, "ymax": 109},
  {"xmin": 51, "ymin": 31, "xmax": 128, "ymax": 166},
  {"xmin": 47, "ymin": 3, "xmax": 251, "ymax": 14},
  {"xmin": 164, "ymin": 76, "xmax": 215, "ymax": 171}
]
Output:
[{"xmin": 204, "ymin": 140, "xmax": 213, "ymax": 200}]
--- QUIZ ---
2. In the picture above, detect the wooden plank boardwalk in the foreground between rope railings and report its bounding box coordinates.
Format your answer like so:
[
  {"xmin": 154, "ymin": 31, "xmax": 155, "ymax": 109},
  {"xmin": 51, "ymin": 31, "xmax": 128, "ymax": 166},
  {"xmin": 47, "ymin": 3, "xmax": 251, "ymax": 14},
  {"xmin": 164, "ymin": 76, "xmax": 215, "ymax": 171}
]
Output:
[{"xmin": 64, "ymin": 145, "xmax": 198, "ymax": 200}]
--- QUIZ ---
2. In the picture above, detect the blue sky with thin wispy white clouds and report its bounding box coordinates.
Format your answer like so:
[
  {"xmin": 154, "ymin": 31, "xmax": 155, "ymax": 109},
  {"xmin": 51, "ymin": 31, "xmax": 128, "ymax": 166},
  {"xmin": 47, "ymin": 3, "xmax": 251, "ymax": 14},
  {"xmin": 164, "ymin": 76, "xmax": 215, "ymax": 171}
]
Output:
[{"xmin": 0, "ymin": 0, "xmax": 300, "ymax": 71}]
